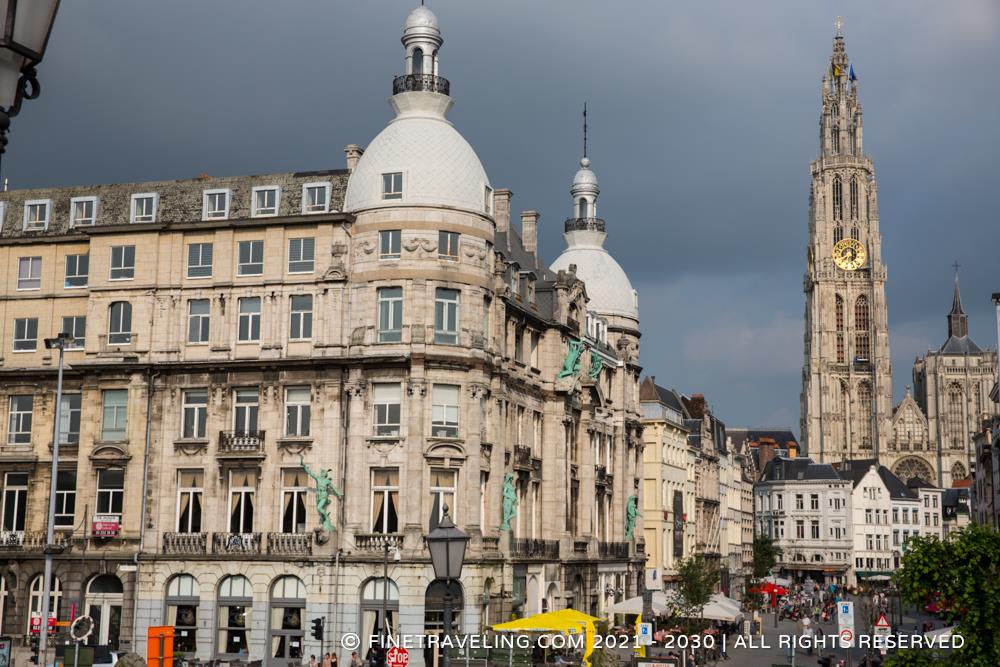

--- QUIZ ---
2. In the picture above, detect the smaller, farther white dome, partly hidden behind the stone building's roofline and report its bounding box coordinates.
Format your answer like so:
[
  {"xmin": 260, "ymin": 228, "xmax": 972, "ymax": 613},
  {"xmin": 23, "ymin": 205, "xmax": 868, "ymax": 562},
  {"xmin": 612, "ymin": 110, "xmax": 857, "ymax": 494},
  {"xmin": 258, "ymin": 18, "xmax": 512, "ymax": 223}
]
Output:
[{"xmin": 550, "ymin": 245, "xmax": 639, "ymax": 321}]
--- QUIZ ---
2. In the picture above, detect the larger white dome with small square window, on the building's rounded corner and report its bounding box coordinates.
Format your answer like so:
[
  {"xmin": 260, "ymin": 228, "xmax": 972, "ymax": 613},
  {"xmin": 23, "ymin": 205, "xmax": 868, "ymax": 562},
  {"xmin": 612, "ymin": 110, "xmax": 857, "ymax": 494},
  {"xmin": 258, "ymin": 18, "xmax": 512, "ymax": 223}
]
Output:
[{"xmin": 344, "ymin": 92, "xmax": 490, "ymax": 215}]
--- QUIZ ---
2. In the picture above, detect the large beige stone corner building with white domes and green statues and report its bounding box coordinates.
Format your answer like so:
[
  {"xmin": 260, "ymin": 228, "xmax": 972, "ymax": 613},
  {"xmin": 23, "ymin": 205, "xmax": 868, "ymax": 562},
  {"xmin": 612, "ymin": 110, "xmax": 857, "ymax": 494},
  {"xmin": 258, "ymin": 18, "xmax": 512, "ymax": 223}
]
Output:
[{"xmin": 0, "ymin": 7, "xmax": 644, "ymax": 665}]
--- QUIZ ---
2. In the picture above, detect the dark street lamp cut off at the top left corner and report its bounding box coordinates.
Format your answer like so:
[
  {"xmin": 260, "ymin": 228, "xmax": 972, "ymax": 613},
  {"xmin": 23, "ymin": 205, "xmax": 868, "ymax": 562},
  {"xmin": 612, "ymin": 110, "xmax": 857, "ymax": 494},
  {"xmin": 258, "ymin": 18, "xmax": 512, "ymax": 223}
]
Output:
[{"xmin": 0, "ymin": 0, "xmax": 60, "ymax": 175}]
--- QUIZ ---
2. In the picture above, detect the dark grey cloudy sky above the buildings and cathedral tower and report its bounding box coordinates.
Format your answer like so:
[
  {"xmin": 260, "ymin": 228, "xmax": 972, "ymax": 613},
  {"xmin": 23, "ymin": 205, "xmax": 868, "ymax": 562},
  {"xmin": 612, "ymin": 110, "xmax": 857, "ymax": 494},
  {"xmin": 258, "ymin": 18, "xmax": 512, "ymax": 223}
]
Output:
[{"xmin": 9, "ymin": 0, "xmax": 1000, "ymax": 431}]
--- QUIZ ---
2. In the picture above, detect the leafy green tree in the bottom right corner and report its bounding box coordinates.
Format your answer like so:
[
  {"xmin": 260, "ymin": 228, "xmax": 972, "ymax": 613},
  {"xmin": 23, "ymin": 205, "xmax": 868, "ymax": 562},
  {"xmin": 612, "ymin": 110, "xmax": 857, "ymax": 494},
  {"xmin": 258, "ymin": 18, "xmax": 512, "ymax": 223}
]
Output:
[{"xmin": 886, "ymin": 524, "xmax": 1000, "ymax": 667}]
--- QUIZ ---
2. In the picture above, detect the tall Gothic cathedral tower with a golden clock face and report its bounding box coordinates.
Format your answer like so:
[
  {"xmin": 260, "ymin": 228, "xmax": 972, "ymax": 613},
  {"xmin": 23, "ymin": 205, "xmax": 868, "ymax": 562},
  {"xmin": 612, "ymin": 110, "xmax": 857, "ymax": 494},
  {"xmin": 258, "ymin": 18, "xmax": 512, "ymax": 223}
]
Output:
[{"xmin": 801, "ymin": 18, "xmax": 892, "ymax": 462}]
